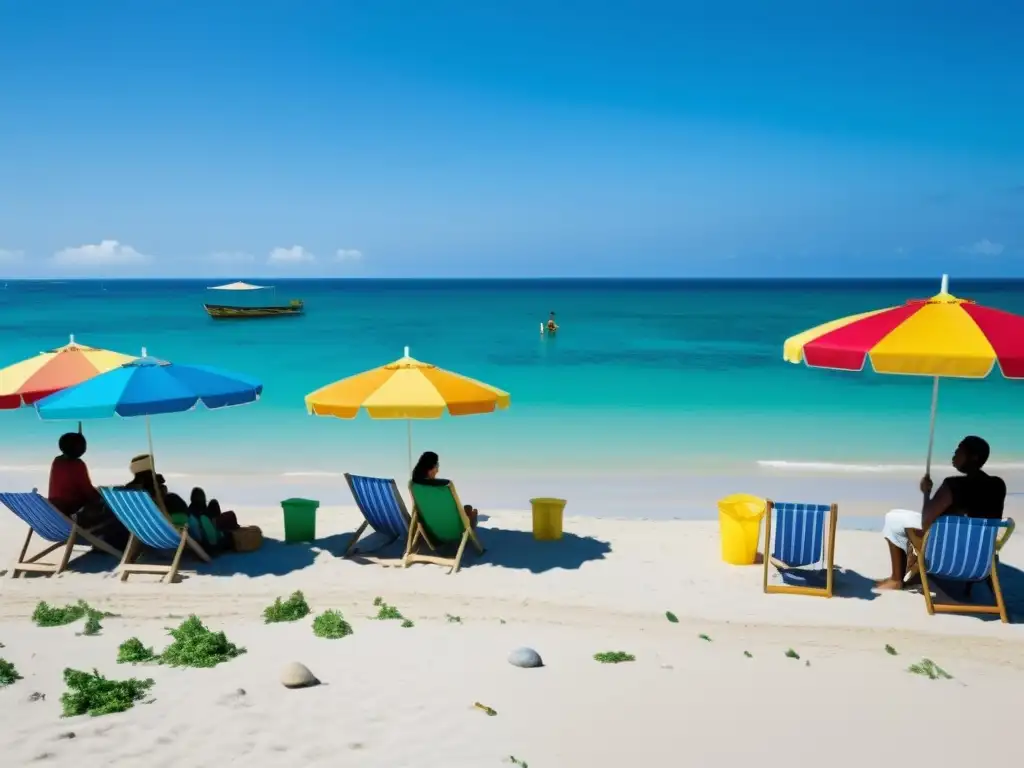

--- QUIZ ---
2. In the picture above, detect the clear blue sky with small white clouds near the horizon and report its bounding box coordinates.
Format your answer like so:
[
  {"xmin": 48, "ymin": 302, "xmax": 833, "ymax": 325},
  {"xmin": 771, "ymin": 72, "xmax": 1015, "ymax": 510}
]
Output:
[{"xmin": 0, "ymin": 0, "xmax": 1024, "ymax": 276}]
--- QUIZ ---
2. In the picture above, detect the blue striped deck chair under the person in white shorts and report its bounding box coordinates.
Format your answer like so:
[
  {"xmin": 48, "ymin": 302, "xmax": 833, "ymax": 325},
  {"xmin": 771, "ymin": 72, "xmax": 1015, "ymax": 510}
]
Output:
[{"xmin": 919, "ymin": 515, "xmax": 1015, "ymax": 624}]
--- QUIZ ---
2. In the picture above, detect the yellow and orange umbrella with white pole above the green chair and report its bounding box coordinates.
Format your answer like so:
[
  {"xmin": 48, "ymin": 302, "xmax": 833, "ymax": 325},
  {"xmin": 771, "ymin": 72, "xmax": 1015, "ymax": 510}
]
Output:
[{"xmin": 305, "ymin": 347, "xmax": 511, "ymax": 468}]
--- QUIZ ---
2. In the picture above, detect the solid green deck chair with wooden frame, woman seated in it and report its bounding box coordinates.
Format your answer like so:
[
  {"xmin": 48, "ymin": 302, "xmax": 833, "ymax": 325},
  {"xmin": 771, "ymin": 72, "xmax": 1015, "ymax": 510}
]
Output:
[{"xmin": 402, "ymin": 482, "xmax": 483, "ymax": 573}]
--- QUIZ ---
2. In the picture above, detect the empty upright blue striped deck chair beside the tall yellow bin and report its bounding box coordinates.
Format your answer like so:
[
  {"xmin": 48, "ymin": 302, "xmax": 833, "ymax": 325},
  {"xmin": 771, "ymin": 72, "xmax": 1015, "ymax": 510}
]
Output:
[{"xmin": 764, "ymin": 501, "xmax": 839, "ymax": 597}]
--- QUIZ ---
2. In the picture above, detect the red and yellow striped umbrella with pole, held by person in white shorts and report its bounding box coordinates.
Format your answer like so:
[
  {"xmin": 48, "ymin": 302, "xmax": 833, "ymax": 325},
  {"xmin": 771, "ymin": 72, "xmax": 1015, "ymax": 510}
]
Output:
[{"xmin": 782, "ymin": 274, "xmax": 1024, "ymax": 479}]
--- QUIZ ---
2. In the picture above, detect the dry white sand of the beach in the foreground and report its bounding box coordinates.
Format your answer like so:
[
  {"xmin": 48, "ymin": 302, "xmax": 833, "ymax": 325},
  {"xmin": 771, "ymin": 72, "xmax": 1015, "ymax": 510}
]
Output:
[{"xmin": 0, "ymin": 508, "xmax": 1024, "ymax": 768}]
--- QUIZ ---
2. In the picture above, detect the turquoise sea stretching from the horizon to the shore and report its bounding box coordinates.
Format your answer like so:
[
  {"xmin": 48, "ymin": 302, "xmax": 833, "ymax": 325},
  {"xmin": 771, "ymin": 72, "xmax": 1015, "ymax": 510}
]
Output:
[{"xmin": 0, "ymin": 279, "xmax": 1024, "ymax": 518}]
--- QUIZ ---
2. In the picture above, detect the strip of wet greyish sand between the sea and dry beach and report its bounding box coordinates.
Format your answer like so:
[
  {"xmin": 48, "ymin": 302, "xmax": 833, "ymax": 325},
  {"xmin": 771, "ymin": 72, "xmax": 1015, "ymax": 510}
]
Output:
[{"xmin": 8, "ymin": 456, "xmax": 1024, "ymax": 529}]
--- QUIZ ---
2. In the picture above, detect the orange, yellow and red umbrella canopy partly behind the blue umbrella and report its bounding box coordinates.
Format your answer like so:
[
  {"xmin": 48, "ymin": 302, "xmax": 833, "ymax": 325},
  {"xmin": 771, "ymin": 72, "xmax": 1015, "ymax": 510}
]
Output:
[{"xmin": 0, "ymin": 336, "xmax": 135, "ymax": 410}]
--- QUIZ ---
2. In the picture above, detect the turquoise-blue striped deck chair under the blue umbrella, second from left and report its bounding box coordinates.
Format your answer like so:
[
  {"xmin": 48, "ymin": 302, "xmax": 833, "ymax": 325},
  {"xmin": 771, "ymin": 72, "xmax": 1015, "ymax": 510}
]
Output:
[{"xmin": 99, "ymin": 487, "xmax": 210, "ymax": 584}]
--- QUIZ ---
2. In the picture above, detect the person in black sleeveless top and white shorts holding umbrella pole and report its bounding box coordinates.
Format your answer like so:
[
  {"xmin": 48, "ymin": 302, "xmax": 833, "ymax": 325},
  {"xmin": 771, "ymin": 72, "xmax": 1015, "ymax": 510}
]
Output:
[{"xmin": 874, "ymin": 435, "xmax": 1007, "ymax": 590}]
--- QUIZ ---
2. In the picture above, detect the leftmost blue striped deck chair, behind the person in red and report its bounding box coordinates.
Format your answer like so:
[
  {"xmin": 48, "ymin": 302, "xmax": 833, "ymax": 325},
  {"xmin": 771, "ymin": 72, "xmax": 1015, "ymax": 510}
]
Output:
[{"xmin": 0, "ymin": 488, "xmax": 121, "ymax": 579}]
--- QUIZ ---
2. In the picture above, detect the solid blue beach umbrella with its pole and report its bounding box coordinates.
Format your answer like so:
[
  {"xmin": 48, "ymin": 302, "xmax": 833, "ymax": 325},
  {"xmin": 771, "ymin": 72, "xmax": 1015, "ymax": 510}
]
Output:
[{"xmin": 35, "ymin": 348, "xmax": 263, "ymax": 487}]
